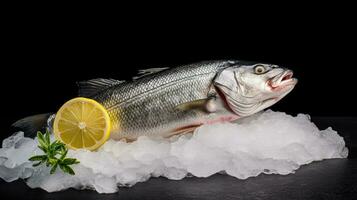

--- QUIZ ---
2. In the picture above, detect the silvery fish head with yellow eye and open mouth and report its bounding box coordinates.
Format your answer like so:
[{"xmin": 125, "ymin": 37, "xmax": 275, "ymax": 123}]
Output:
[{"xmin": 214, "ymin": 63, "xmax": 297, "ymax": 117}]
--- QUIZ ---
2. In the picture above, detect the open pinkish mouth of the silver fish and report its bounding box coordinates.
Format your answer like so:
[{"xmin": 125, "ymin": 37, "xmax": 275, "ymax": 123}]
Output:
[{"xmin": 267, "ymin": 70, "xmax": 297, "ymax": 91}]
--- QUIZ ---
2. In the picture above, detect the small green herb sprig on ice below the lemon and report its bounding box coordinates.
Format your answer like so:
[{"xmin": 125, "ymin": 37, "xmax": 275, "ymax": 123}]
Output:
[{"xmin": 29, "ymin": 130, "xmax": 79, "ymax": 175}]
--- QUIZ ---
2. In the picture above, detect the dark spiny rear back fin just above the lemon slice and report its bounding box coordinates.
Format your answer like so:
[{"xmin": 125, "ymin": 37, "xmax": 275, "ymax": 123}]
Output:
[{"xmin": 77, "ymin": 78, "xmax": 125, "ymax": 97}]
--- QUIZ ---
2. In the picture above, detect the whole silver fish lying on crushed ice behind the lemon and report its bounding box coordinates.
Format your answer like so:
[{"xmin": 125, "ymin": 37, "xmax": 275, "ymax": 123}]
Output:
[{"xmin": 14, "ymin": 60, "xmax": 297, "ymax": 141}]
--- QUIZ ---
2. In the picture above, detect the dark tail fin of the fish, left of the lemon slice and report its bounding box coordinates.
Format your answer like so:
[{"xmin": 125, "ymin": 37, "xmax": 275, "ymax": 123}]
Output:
[{"xmin": 11, "ymin": 113, "xmax": 54, "ymax": 138}]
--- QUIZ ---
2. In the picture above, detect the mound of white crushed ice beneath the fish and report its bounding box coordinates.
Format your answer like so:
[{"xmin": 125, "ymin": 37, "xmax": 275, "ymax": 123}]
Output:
[{"xmin": 0, "ymin": 110, "xmax": 348, "ymax": 193}]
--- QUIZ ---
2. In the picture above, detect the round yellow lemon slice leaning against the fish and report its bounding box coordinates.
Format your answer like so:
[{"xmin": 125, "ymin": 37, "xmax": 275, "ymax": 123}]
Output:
[{"xmin": 53, "ymin": 97, "xmax": 111, "ymax": 150}]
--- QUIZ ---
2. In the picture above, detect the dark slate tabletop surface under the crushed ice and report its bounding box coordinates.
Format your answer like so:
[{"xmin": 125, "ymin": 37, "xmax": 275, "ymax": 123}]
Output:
[{"xmin": 0, "ymin": 117, "xmax": 357, "ymax": 200}]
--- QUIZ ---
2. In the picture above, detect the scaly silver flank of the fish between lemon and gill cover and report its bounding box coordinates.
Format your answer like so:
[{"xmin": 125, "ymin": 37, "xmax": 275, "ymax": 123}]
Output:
[{"xmin": 93, "ymin": 61, "xmax": 228, "ymax": 139}]
